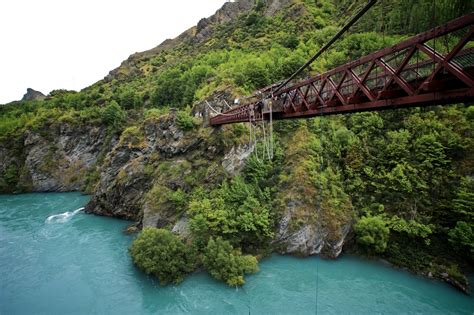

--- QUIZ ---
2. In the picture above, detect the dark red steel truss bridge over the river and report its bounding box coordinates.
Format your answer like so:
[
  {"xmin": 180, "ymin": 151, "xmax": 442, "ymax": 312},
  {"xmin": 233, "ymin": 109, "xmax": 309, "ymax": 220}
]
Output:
[{"xmin": 210, "ymin": 13, "xmax": 474, "ymax": 126}]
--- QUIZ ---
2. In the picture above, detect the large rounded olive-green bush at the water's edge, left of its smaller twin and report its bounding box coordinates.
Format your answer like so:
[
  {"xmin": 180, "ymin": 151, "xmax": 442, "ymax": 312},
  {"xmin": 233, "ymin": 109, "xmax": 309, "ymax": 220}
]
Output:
[{"xmin": 129, "ymin": 228, "xmax": 195, "ymax": 285}]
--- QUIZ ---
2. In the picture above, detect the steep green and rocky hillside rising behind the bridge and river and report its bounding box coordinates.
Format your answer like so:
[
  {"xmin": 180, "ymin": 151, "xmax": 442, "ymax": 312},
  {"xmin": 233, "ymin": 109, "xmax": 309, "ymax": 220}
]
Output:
[{"xmin": 0, "ymin": 0, "xmax": 474, "ymax": 289}]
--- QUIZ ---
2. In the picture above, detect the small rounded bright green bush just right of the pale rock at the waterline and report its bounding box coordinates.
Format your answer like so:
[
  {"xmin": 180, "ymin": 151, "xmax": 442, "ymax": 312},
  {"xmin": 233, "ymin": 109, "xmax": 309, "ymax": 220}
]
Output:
[{"xmin": 354, "ymin": 216, "xmax": 390, "ymax": 253}]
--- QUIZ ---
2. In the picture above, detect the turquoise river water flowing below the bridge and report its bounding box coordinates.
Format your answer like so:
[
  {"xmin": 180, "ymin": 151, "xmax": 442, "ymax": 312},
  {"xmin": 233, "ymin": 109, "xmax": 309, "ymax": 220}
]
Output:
[{"xmin": 0, "ymin": 193, "xmax": 474, "ymax": 314}]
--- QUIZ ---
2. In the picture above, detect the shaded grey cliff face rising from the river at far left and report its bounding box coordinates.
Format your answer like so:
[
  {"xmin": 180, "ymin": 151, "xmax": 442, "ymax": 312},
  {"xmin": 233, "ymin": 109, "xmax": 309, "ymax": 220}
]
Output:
[{"xmin": 0, "ymin": 124, "xmax": 110, "ymax": 192}]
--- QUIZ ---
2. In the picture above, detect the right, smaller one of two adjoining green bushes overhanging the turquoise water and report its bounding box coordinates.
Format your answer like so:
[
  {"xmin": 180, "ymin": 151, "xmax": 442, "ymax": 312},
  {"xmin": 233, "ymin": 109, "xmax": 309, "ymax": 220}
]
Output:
[{"xmin": 203, "ymin": 237, "xmax": 258, "ymax": 286}]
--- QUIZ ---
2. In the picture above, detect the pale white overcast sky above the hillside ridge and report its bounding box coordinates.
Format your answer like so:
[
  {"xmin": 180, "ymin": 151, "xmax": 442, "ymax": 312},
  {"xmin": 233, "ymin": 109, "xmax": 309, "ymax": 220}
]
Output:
[{"xmin": 0, "ymin": 0, "xmax": 226, "ymax": 104}]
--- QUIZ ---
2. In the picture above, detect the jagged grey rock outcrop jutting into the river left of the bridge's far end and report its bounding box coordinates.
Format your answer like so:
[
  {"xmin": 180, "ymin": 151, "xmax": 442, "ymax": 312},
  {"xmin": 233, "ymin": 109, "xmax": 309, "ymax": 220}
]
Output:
[{"xmin": 86, "ymin": 113, "xmax": 201, "ymax": 221}]
